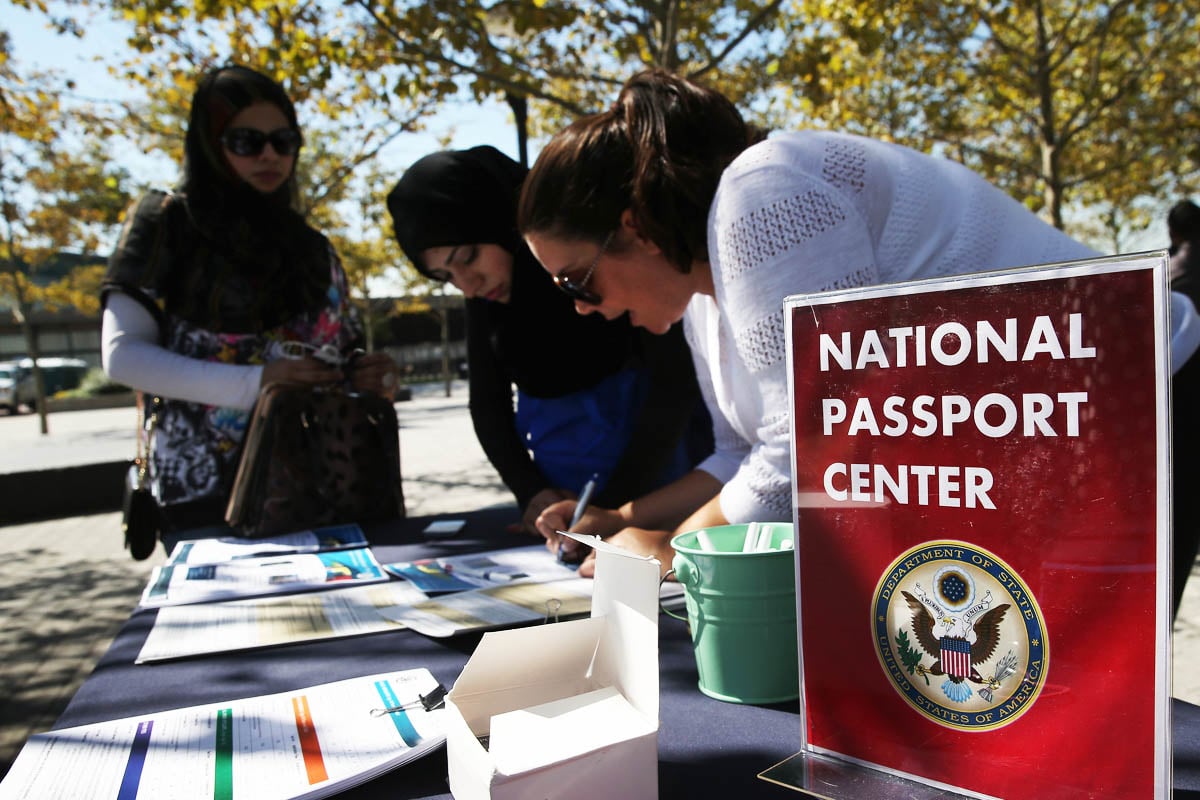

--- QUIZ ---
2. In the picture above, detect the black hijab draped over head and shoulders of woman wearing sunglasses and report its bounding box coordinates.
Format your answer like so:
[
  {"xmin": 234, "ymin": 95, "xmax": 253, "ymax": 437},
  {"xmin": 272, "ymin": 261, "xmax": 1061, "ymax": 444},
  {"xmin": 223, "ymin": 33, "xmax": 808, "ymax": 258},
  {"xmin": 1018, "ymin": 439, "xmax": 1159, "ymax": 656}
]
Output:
[{"xmin": 106, "ymin": 66, "xmax": 330, "ymax": 333}]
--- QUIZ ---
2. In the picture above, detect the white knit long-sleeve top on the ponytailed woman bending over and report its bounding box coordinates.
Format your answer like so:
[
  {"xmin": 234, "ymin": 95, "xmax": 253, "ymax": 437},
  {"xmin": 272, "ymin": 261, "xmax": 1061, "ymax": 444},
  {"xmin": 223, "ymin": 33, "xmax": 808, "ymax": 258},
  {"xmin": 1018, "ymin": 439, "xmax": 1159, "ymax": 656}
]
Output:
[{"xmin": 684, "ymin": 131, "xmax": 1200, "ymax": 523}]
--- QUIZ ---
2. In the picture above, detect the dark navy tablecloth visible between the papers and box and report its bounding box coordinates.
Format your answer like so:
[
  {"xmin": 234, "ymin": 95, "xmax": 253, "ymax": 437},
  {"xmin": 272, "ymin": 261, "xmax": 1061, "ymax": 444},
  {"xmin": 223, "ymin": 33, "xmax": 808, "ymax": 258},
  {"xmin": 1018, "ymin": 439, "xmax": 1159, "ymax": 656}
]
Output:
[{"xmin": 54, "ymin": 506, "xmax": 1200, "ymax": 800}]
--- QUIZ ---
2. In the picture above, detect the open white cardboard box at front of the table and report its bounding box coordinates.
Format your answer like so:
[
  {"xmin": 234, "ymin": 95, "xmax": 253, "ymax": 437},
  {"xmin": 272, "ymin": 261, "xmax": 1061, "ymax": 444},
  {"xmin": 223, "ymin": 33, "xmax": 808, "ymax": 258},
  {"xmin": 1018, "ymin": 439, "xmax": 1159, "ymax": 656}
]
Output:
[{"xmin": 446, "ymin": 534, "xmax": 660, "ymax": 800}]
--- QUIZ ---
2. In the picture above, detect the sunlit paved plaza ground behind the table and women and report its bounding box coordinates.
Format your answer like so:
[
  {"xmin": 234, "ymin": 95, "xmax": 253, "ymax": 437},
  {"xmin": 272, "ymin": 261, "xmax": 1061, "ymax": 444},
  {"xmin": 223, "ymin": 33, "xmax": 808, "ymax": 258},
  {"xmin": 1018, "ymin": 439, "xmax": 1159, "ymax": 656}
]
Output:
[{"xmin": 0, "ymin": 381, "xmax": 1200, "ymax": 776}]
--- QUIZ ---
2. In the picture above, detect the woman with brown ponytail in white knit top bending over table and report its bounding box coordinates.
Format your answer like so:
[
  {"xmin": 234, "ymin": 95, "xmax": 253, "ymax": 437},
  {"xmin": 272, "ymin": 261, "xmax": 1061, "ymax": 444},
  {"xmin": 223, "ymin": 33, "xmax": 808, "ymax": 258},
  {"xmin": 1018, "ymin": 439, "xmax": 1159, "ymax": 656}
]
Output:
[{"xmin": 518, "ymin": 65, "xmax": 1200, "ymax": 573}]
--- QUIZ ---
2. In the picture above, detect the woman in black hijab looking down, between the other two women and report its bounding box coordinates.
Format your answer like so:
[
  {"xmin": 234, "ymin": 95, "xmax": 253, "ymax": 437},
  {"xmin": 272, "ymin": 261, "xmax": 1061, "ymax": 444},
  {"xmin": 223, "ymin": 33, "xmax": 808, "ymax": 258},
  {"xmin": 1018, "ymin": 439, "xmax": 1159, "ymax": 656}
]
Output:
[{"xmin": 388, "ymin": 146, "xmax": 712, "ymax": 535}]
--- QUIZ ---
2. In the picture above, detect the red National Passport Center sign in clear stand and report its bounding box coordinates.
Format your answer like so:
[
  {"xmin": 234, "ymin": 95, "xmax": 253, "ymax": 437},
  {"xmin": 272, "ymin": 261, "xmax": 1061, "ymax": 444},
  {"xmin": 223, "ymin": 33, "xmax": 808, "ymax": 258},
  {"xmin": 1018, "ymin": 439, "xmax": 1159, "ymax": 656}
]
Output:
[{"xmin": 786, "ymin": 255, "xmax": 1170, "ymax": 799}]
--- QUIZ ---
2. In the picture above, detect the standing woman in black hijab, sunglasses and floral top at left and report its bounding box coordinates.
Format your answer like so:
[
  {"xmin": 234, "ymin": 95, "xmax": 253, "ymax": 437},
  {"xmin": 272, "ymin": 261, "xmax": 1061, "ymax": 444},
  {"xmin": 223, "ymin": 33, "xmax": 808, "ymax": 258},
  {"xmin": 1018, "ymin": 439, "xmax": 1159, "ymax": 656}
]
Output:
[{"xmin": 101, "ymin": 66, "xmax": 395, "ymax": 546}]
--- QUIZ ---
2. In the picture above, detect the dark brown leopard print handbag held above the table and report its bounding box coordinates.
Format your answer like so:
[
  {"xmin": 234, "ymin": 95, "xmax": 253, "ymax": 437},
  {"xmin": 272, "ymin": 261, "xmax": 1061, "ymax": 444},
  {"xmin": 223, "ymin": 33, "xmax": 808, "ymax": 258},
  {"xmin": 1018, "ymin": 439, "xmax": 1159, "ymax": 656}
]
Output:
[{"xmin": 226, "ymin": 384, "xmax": 404, "ymax": 537}]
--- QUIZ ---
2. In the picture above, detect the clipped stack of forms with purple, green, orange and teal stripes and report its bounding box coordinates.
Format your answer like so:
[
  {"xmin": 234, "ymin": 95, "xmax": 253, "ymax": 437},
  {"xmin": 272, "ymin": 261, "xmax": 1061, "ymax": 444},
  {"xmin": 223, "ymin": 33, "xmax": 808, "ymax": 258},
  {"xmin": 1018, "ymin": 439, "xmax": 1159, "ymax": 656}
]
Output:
[{"xmin": 0, "ymin": 669, "xmax": 445, "ymax": 800}]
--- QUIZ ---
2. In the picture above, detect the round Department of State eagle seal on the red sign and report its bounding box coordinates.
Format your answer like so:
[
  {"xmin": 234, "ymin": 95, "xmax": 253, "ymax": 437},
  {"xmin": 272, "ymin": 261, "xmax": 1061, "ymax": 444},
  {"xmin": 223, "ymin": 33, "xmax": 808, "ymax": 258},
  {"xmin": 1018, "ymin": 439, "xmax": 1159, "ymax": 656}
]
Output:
[{"xmin": 871, "ymin": 540, "xmax": 1049, "ymax": 730}]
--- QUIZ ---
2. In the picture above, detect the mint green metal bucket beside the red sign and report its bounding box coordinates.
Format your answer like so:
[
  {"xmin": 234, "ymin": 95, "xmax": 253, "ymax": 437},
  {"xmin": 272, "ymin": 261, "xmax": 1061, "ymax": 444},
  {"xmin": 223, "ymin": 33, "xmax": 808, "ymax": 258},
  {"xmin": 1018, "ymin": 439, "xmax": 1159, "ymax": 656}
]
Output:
[{"xmin": 671, "ymin": 522, "xmax": 800, "ymax": 703}]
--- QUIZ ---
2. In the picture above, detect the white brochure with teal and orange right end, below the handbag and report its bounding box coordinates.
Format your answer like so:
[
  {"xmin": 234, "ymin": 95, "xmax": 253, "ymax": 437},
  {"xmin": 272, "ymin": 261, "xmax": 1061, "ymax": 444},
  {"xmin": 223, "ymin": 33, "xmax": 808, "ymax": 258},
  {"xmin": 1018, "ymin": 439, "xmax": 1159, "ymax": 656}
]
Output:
[{"xmin": 140, "ymin": 547, "xmax": 388, "ymax": 607}]
